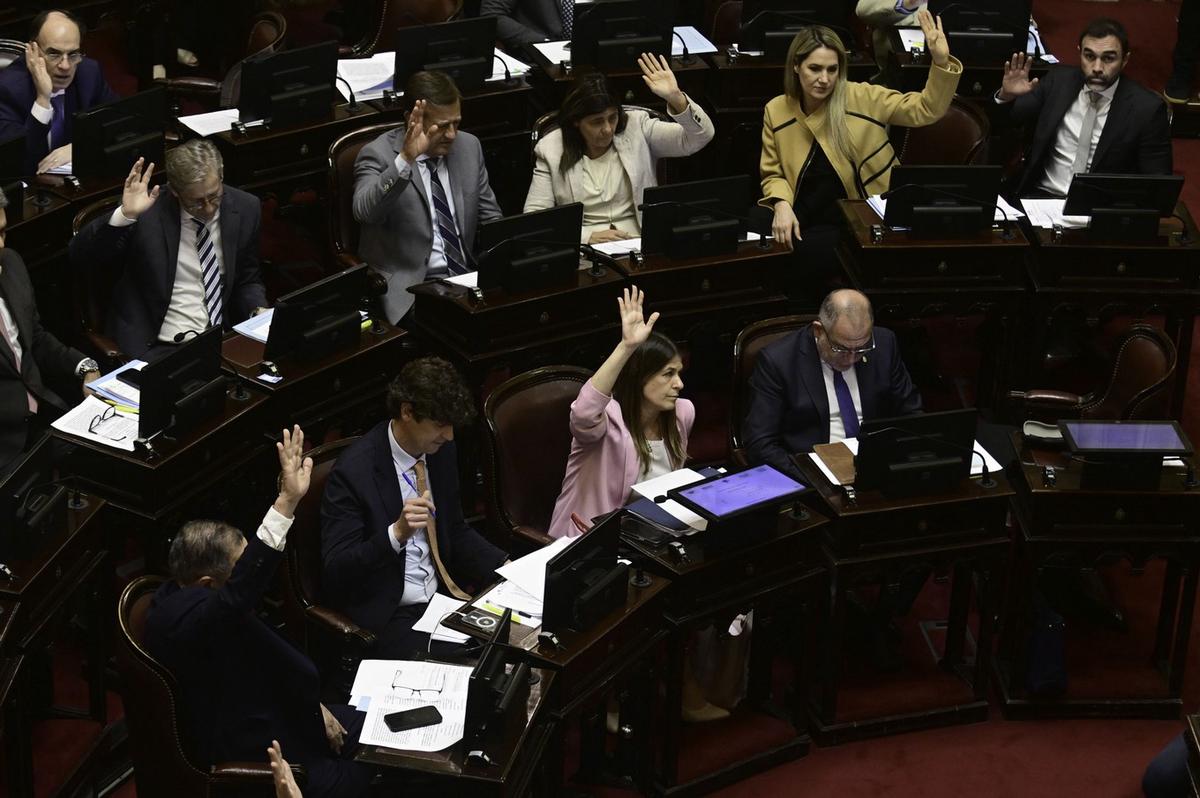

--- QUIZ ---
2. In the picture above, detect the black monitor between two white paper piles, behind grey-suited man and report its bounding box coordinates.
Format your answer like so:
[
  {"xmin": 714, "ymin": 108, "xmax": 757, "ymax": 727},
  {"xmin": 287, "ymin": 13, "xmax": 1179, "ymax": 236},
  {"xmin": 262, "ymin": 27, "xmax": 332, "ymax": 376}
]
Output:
[{"xmin": 238, "ymin": 42, "xmax": 337, "ymax": 127}]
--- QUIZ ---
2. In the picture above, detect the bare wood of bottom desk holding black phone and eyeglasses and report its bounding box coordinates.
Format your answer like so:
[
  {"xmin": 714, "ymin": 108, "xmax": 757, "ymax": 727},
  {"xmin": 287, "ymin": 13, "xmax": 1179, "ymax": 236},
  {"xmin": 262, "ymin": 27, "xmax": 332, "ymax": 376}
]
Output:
[{"xmin": 355, "ymin": 668, "xmax": 557, "ymax": 798}]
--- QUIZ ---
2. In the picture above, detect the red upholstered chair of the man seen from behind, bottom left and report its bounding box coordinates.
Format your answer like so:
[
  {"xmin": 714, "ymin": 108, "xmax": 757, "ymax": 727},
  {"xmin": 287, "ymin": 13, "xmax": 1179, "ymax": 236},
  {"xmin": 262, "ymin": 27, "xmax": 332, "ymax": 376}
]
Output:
[{"xmin": 116, "ymin": 576, "xmax": 305, "ymax": 798}]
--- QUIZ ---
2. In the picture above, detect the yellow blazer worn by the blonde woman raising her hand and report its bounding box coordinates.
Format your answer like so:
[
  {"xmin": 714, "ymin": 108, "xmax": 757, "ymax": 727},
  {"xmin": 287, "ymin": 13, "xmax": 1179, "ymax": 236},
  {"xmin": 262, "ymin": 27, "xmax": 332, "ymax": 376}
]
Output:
[{"xmin": 758, "ymin": 56, "xmax": 962, "ymax": 206}]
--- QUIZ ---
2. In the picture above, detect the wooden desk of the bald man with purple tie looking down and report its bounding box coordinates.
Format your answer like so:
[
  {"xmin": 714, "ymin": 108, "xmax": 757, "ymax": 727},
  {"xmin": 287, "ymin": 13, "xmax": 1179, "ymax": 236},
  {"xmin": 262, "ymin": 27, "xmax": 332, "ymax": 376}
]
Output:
[{"xmin": 799, "ymin": 456, "xmax": 1014, "ymax": 745}]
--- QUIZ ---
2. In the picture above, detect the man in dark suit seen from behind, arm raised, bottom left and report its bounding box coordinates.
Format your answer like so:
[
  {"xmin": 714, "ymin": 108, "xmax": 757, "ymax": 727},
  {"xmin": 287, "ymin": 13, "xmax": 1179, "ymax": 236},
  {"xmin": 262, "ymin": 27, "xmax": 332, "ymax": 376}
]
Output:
[{"xmin": 145, "ymin": 426, "xmax": 372, "ymax": 798}]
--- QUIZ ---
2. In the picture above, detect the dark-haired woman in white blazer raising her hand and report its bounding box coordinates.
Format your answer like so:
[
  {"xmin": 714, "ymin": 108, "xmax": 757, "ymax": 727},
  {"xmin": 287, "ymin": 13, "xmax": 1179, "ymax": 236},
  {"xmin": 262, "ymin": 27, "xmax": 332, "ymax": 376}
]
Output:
[{"xmin": 524, "ymin": 53, "xmax": 714, "ymax": 244}]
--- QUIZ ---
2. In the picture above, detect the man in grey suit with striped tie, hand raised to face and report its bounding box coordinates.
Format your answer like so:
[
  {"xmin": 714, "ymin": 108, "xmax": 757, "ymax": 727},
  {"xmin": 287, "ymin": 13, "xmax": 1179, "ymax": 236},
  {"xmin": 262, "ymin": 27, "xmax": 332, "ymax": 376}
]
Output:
[{"xmin": 354, "ymin": 72, "xmax": 500, "ymax": 323}]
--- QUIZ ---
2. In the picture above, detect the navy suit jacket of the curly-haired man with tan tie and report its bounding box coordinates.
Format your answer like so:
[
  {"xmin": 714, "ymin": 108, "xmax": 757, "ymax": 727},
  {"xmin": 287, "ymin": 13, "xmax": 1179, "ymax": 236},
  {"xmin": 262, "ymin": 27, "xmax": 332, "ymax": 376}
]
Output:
[{"xmin": 320, "ymin": 421, "xmax": 505, "ymax": 631}]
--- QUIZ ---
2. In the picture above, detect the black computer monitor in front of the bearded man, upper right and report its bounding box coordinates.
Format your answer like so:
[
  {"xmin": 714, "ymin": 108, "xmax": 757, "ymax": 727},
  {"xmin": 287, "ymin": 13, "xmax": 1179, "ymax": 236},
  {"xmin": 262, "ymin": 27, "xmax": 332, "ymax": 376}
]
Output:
[{"xmin": 1062, "ymin": 173, "xmax": 1183, "ymax": 241}]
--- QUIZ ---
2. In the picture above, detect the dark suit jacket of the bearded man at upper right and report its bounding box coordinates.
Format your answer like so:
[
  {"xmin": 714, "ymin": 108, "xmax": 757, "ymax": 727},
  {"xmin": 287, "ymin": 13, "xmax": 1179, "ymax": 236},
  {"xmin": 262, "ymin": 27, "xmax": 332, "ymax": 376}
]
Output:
[{"xmin": 990, "ymin": 65, "xmax": 1171, "ymax": 196}]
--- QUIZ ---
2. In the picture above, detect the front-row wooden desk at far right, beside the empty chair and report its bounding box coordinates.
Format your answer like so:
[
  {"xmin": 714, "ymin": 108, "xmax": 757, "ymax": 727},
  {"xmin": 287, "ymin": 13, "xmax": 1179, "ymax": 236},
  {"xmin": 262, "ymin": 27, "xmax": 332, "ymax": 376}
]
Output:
[{"xmin": 995, "ymin": 436, "xmax": 1200, "ymax": 718}]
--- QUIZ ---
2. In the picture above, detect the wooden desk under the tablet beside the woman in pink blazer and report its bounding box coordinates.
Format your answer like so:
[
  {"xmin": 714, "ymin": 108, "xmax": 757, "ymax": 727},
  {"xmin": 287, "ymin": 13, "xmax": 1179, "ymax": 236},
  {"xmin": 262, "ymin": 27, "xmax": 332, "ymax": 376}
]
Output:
[{"xmin": 623, "ymin": 508, "xmax": 828, "ymax": 794}]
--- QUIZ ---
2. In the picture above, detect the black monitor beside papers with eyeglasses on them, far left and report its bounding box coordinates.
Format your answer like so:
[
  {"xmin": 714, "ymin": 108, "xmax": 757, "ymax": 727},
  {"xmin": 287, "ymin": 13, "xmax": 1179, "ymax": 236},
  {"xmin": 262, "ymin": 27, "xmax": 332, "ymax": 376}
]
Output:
[{"xmin": 138, "ymin": 326, "xmax": 226, "ymax": 439}]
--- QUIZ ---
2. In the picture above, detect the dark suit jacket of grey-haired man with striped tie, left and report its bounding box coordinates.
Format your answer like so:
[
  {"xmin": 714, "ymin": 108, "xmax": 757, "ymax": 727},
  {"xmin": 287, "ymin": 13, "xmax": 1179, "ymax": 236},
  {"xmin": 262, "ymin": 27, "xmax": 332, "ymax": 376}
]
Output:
[{"xmin": 71, "ymin": 186, "xmax": 266, "ymax": 358}]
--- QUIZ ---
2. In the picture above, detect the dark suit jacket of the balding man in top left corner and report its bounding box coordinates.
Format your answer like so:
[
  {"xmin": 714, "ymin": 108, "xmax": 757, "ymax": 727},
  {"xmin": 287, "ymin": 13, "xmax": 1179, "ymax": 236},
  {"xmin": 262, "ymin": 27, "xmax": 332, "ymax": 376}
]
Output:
[{"xmin": 0, "ymin": 58, "xmax": 116, "ymax": 174}]
